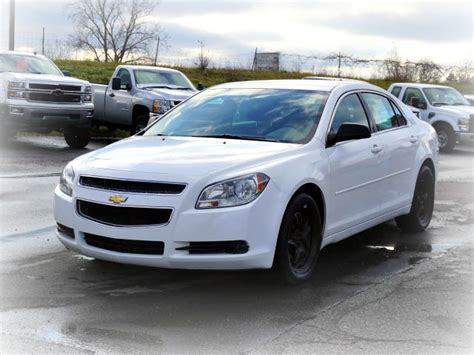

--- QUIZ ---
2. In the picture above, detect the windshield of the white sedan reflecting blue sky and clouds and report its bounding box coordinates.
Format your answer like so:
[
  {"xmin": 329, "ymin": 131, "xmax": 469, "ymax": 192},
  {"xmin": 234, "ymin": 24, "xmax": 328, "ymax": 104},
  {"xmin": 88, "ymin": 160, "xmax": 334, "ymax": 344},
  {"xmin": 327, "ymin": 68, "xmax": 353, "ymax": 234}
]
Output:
[{"xmin": 144, "ymin": 88, "xmax": 328, "ymax": 143}]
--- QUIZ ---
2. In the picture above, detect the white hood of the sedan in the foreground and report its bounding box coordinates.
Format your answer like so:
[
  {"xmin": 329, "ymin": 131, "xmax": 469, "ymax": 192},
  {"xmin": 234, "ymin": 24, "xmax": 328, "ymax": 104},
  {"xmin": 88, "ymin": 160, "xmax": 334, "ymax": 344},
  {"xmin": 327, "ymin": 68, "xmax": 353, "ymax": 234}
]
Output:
[{"xmin": 81, "ymin": 136, "xmax": 300, "ymax": 182}]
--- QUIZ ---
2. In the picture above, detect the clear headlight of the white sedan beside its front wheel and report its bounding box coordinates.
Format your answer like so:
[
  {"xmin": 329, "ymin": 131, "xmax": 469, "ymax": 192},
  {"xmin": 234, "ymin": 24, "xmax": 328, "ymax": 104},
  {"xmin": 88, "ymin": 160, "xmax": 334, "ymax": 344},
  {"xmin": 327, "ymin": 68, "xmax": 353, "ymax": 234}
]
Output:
[{"xmin": 196, "ymin": 173, "xmax": 270, "ymax": 209}]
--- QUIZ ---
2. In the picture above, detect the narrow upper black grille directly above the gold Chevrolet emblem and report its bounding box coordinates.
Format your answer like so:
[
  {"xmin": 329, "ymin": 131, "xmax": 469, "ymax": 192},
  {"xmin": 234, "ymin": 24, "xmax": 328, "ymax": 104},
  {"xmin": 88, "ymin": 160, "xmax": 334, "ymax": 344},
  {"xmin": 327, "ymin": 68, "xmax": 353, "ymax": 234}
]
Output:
[{"xmin": 79, "ymin": 176, "xmax": 186, "ymax": 195}]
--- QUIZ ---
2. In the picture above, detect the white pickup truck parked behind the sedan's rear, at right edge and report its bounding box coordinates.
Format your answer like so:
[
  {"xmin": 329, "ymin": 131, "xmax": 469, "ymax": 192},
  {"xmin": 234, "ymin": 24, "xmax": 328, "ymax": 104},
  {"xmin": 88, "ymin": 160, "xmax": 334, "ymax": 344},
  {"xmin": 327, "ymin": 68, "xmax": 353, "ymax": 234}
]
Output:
[{"xmin": 388, "ymin": 83, "xmax": 474, "ymax": 152}]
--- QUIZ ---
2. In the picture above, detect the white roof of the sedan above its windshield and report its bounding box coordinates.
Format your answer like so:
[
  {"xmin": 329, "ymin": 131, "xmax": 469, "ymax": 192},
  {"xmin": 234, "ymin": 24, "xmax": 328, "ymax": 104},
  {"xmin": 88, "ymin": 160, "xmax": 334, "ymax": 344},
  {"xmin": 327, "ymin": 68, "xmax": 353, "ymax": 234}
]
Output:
[{"xmin": 214, "ymin": 79, "xmax": 381, "ymax": 91}]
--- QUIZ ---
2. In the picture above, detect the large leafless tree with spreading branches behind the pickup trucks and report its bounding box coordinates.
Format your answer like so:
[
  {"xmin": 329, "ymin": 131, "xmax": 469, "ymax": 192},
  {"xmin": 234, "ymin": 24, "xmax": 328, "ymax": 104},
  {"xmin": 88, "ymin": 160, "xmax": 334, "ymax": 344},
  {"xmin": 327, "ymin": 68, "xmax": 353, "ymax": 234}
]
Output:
[{"xmin": 69, "ymin": 0, "xmax": 158, "ymax": 62}]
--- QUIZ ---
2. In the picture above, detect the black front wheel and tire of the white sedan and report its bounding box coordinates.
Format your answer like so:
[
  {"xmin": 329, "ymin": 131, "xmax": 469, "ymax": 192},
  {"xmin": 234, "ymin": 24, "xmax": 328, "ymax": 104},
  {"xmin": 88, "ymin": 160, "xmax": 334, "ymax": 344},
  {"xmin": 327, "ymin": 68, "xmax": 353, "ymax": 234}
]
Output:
[{"xmin": 273, "ymin": 193, "xmax": 322, "ymax": 284}]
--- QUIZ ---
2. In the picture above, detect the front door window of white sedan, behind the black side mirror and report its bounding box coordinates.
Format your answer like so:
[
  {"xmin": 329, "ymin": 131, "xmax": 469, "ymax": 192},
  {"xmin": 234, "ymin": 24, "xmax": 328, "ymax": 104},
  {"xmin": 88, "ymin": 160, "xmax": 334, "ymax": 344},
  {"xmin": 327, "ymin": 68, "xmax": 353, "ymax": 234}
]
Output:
[{"xmin": 330, "ymin": 94, "xmax": 370, "ymax": 134}]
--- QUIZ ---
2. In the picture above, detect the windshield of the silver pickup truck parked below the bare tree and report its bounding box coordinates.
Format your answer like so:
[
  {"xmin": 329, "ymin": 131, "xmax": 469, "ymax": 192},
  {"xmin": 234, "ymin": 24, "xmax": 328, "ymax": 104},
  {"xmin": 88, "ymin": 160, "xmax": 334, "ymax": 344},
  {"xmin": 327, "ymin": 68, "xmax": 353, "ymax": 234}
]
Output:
[{"xmin": 135, "ymin": 69, "xmax": 194, "ymax": 90}]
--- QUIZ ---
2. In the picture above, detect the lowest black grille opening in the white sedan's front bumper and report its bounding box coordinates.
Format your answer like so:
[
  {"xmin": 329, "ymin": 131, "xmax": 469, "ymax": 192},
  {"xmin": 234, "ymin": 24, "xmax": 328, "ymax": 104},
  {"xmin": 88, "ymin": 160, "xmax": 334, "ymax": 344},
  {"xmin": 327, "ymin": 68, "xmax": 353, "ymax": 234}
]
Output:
[{"xmin": 84, "ymin": 233, "xmax": 165, "ymax": 255}]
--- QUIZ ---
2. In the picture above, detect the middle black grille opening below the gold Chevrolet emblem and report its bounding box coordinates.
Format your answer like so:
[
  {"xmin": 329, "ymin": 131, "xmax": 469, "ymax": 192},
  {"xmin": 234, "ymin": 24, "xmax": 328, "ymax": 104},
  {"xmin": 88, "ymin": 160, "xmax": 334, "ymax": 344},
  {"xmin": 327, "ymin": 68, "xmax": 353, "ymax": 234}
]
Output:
[{"xmin": 77, "ymin": 200, "xmax": 173, "ymax": 226}]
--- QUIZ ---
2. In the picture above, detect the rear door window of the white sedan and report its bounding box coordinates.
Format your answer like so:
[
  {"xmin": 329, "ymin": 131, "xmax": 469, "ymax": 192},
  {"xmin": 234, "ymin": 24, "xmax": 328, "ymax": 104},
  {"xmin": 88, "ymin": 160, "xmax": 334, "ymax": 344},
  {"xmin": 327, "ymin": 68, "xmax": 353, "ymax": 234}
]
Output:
[{"xmin": 362, "ymin": 92, "xmax": 400, "ymax": 131}]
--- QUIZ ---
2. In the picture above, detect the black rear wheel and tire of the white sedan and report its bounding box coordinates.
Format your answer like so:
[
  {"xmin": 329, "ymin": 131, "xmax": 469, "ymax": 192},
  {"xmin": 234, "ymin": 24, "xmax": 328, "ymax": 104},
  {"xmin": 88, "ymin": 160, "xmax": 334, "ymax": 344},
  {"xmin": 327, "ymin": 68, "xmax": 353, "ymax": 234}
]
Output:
[{"xmin": 395, "ymin": 165, "xmax": 435, "ymax": 233}]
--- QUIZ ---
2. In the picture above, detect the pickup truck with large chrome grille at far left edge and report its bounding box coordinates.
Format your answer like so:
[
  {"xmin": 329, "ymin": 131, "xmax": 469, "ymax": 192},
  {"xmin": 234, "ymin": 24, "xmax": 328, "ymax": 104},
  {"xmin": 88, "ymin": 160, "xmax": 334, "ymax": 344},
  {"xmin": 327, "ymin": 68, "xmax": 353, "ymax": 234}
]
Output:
[{"xmin": 0, "ymin": 51, "xmax": 94, "ymax": 148}]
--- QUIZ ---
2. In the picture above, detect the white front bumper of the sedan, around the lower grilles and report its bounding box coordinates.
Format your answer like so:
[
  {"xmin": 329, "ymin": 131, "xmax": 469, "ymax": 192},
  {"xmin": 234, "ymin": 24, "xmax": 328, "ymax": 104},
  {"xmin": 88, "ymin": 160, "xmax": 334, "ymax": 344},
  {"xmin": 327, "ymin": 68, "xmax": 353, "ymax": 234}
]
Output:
[{"xmin": 54, "ymin": 184, "xmax": 281, "ymax": 270}]
